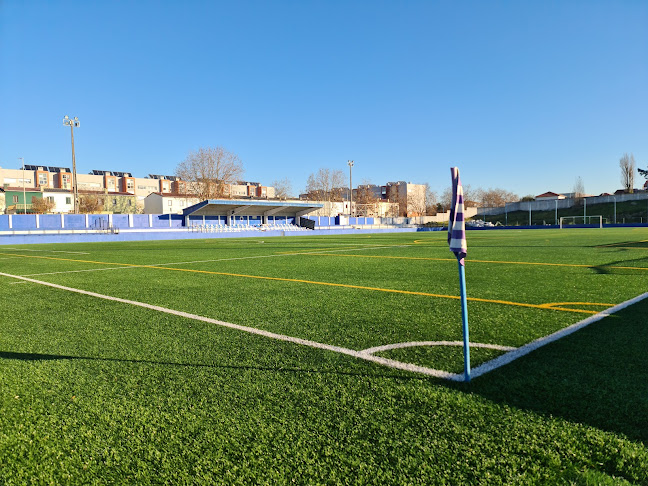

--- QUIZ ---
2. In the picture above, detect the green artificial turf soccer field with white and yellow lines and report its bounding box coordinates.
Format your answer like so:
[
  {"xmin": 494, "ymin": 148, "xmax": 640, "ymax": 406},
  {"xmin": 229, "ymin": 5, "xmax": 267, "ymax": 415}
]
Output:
[{"xmin": 0, "ymin": 228, "xmax": 648, "ymax": 484}]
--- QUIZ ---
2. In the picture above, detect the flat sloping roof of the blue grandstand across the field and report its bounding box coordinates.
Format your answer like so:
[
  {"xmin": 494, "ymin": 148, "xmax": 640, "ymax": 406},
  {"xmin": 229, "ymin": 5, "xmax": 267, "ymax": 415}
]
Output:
[{"xmin": 182, "ymin": 199, "xmax": 324, "ymax": 216}]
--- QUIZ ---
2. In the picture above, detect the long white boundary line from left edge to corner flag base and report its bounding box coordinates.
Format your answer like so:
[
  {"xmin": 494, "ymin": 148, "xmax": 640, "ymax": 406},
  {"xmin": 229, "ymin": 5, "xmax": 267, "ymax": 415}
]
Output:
[{"xmin": 0, "ymin": 272, "xmax": 463, "ymax": 381}]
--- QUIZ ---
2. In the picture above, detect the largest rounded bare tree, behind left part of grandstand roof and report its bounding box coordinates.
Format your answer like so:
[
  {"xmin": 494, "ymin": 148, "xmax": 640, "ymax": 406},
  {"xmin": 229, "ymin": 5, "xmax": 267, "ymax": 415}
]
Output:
[{"xmin": 176, "ymin": 146, "xmax": 244, "ymax": 199}]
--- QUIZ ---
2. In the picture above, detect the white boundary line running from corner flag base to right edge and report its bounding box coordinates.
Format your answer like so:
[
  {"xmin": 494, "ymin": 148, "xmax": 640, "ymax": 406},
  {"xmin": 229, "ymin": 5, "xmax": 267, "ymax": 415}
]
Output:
[{"xmin": 471, "ymin": 292, "xmax": 648, "ymax": 378}]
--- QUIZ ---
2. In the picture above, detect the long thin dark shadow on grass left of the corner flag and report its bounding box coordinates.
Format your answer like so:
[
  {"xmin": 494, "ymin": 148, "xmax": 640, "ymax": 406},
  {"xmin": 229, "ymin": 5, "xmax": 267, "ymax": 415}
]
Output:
[{"xmin": 0, "ymin": 351, "xmax": 429, "ymax": 381}]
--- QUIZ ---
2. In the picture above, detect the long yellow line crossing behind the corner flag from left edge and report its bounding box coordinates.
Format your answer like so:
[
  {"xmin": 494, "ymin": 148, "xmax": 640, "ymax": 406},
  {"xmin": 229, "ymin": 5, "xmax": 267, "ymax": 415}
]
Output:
[{"xmin": 0, "ymin": 253, "xmax": 596, "ymax": 314}]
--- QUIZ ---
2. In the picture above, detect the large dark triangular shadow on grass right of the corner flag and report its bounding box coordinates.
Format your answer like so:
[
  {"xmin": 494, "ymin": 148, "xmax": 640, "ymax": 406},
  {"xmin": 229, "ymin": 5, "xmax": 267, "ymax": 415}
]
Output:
[{"xmin": 456, "ymin": 300, "xmax": 648, "ymax": 443}]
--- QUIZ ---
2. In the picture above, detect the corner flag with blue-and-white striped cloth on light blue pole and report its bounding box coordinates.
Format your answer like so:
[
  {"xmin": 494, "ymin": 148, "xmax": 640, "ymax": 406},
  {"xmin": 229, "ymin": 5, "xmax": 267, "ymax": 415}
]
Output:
[{"xmin": 448, "ymin": 167, "xmax": 470, "ymax": 382}]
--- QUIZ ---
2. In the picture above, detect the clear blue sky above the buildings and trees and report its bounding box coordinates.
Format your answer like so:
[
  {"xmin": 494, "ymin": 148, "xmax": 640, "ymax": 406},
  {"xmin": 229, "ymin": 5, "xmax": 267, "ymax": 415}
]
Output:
[{"xmin": 0, "ymin": 0, "xmax": 648, "ymax": 196}]
